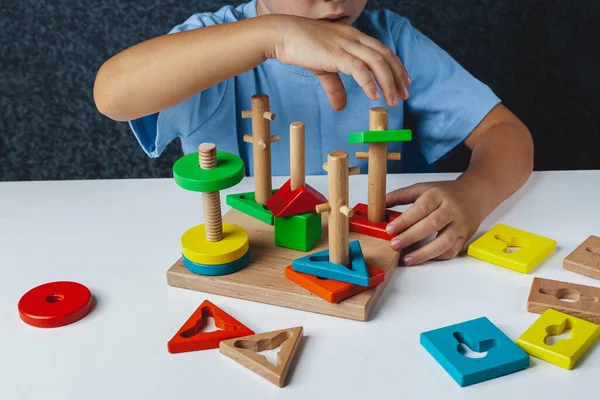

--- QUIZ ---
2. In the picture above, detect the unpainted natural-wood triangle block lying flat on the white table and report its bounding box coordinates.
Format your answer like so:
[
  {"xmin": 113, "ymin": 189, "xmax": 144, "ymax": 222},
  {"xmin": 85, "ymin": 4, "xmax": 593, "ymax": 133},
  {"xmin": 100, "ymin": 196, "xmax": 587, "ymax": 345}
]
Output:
[{"xmin": 219, "ymin": 326, "xmax": 303, "ymax": 387}]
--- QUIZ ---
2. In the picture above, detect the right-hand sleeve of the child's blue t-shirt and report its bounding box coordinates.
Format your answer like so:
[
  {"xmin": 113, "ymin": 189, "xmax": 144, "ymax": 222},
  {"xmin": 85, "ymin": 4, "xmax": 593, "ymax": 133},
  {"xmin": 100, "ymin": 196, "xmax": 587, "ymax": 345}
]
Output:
[{"xmin": 396, "ymin": 19, "xmax": 500, "ymax": 163}]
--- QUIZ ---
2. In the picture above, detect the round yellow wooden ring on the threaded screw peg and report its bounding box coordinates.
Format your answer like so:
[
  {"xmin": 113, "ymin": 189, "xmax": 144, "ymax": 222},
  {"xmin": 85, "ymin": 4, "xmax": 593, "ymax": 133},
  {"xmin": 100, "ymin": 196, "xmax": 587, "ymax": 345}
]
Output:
[{"xmin": 181, "ymin": 222, "xmax": 250, "ymax": 265}]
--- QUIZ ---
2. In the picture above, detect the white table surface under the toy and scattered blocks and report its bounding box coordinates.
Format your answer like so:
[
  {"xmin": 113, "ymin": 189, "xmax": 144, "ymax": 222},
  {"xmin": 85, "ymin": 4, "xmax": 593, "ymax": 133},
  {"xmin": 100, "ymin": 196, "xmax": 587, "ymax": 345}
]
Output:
[{"xmin": 0, "ymin": 171, "xmax": 600, "ymax": 400}]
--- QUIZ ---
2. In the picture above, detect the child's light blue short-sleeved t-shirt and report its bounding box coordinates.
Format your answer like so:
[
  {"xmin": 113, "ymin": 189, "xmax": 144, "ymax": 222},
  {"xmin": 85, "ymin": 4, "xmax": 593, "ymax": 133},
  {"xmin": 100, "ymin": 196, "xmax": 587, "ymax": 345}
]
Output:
[{"xmin": 130, "ymin": 0, "xmax": 499, "ymax": 175}]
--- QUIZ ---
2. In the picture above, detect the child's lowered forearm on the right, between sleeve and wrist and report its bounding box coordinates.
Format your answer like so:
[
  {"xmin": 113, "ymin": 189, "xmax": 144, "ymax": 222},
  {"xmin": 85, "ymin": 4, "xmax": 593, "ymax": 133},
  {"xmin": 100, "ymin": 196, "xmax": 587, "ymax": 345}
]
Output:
[{"xmin": 458, "ymin": 107, "xmax": 534, "ymax": 219}]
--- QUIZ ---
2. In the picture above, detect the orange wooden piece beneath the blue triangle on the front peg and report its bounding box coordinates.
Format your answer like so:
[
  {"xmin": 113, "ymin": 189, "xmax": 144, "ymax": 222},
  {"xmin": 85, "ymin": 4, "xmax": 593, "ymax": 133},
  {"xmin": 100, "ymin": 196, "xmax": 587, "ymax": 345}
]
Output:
[{"xmin": 285, "ymin": 264, "xmax": 385, "ymax": 303}]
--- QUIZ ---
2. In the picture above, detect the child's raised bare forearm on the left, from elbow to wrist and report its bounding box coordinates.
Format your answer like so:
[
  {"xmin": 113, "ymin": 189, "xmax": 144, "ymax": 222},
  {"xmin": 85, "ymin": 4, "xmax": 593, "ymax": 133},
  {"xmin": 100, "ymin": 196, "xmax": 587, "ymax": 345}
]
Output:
[{"xmin": 94, "ymin": 16, "xmax": 275, "ymax": 121}]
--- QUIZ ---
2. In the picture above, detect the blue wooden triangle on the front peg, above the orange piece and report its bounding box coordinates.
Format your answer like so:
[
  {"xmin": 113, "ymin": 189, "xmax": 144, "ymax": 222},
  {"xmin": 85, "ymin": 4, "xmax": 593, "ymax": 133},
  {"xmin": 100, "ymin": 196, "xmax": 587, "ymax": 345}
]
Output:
[{"xmin": 292, "ymin": 240, "xmax": 369, "ymax": 286}]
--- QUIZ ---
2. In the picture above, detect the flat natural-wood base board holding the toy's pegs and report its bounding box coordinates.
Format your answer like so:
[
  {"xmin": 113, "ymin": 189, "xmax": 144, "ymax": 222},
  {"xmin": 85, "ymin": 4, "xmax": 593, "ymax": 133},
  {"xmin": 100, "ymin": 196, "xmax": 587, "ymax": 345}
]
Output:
[{"xmin": 167, "ymin": 209, "xmax": 399, "ymax": 321}]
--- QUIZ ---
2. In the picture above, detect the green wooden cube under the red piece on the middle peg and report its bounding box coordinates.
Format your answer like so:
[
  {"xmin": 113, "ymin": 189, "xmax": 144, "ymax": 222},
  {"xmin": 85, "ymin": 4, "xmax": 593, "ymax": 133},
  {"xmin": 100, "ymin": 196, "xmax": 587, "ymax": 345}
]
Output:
[{"xmin": 275, "ymin": 213, "xmax": 322, "ymax": 251}]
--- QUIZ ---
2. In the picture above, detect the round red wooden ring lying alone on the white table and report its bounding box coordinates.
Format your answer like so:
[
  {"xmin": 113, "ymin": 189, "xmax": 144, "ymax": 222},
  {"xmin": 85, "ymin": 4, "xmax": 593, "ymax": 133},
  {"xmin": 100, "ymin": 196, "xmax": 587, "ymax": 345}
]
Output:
[{"xmin": 19, "ymin": 281, "xmax": 92, "ymax": 328}]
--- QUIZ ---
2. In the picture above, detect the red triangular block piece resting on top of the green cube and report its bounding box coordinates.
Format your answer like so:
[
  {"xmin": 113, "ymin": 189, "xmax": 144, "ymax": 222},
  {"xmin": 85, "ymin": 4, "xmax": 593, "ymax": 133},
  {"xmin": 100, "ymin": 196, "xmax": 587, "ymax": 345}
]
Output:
[{"xmin": 266, "ymin": 179, "xmax": 327, "ymax": 217}]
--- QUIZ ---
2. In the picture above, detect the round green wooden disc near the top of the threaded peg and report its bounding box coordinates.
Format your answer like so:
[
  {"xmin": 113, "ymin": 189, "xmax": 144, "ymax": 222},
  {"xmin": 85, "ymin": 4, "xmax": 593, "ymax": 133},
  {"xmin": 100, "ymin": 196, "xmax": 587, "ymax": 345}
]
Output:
[{"xmin": 173, "ymin": 151, "xmax": 244, "ymax": 192}]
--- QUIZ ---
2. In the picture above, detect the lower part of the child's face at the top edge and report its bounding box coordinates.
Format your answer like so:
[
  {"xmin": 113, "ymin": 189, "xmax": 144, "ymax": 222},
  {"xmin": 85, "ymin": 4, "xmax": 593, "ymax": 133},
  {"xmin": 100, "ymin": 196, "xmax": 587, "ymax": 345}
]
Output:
[{"xmin": 258, "ymin": 0, "xmax": 367, "ymax": 25}]
